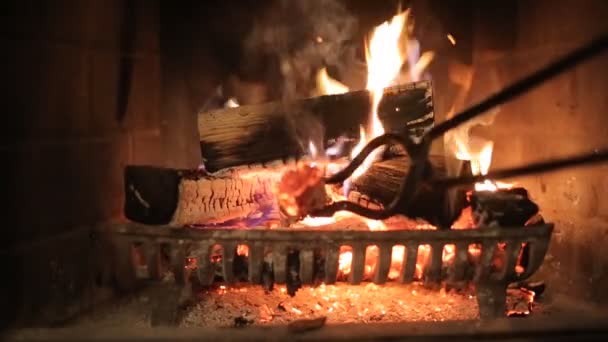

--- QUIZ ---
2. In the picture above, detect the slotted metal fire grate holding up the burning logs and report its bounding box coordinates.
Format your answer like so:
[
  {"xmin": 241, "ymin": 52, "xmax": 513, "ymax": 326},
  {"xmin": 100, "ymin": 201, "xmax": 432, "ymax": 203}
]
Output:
[{"xmin": 107, "ymin": 223, "xmax": 553, "ymax": 318}]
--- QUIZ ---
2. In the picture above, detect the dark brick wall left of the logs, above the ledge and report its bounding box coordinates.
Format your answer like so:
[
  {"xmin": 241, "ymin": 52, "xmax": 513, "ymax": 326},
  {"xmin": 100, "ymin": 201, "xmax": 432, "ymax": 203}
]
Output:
[{"xmin": 0, "ymin": 0, "xmax": 163, "ymax": 243}]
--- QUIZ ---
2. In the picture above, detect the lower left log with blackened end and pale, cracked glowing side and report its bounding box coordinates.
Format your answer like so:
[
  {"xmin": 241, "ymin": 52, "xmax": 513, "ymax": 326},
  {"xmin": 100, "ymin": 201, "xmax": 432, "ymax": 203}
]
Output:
[{"xmin": 124, "ymin": 165, "xmax": 278, "ymax": 226}]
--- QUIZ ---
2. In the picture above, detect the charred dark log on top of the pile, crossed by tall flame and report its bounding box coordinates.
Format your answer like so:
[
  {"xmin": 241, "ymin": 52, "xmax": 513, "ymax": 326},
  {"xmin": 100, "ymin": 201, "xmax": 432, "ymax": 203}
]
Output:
[{"xmin": 198, "ymin": 81, "xmax": 434, "ymax": 171}]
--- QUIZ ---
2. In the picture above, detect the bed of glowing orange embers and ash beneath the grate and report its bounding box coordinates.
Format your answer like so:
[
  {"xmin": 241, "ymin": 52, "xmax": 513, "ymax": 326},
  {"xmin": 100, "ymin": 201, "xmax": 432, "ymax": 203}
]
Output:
[{"xmin": 182, "ymin": 283, "xmax": 543, "ymax": 327}]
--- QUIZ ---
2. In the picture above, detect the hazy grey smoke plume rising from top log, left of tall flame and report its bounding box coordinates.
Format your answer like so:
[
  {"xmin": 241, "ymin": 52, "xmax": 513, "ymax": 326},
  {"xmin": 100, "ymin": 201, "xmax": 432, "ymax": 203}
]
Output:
[{"xmin": 244, "ymin": 0, "xmax": 357, "ymax": 155}]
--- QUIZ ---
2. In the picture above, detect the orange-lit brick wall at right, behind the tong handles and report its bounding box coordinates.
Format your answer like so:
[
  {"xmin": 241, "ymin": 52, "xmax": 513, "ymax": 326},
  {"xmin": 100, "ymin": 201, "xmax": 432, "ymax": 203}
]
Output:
[{"xmin": 474, "ymin": 0, "xmax": 608, "ymax": 302}]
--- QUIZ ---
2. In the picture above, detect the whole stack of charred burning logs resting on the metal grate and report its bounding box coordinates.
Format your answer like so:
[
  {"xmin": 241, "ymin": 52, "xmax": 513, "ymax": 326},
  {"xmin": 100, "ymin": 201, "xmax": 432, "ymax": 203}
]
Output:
[{"xmin": 125, "ymin": 81, "xmax": 460, "ymax": 227}]
